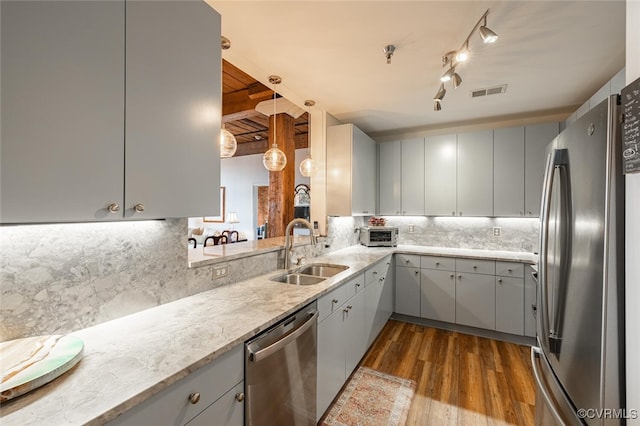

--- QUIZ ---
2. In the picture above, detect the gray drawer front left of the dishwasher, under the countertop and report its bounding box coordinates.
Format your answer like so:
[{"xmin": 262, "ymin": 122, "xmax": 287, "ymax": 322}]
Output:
[{"xmin": 109, "ymin": 345, "xmax": 244, "ymax": 426}]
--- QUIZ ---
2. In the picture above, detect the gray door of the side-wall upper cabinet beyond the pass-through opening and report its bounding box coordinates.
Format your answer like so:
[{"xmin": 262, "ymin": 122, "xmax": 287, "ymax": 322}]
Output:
[{"xmin": 351, "ymin": 126, "xmax": 376, "ymax": 216}]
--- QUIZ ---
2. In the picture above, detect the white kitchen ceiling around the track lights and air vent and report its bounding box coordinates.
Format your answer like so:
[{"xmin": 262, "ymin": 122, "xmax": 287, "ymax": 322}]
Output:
[{"xmin": 207, "ymin": 0, "xmax": 626, "ymax": 135}]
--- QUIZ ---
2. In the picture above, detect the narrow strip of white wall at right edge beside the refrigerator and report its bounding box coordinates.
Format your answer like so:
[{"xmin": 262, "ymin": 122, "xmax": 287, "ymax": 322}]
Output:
[{"xmin": 625, "ymin": 0, "xmax": 640, "ymax": 425}]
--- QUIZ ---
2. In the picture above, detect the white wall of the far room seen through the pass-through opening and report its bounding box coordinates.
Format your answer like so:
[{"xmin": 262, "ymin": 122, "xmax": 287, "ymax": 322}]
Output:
[{"xmin": 189, "ymin": 149, "xmax": 313, "ymax": 240}]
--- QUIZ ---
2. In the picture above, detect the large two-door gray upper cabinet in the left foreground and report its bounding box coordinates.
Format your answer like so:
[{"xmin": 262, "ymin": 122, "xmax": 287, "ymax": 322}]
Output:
[{"xmin": 0, "ymin": 1, "xmax": 221, "ymax": 223}]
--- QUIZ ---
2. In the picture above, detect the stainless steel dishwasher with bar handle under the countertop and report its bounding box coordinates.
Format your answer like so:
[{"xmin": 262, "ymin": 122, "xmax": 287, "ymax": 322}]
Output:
[{"xmin": 244, "ymin": 302, "xmax": 318, "ymax": 426}]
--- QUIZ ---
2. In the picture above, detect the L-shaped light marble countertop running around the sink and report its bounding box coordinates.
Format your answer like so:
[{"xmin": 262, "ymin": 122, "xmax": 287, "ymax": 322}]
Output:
[{"xmin": 0, "ymin": 246, "xmax": 537, "ymax": 426}]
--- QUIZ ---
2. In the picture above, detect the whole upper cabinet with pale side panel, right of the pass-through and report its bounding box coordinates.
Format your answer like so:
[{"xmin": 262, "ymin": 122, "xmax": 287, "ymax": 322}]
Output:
[{"xmin": 327, "ymin": 124, "xmax": 376, "ymax": 216}]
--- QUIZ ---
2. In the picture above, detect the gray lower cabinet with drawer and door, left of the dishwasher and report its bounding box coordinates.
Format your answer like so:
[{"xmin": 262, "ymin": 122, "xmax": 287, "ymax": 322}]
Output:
[{"xmin": 108, "ymin": 345, "xmax": 244, "ymax": 426}]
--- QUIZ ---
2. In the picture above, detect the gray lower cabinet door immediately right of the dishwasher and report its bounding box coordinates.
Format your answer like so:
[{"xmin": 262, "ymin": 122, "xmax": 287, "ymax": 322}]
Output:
[{"xmin": 316, "ymin": 310, "xmax": 345, "ymax": 420}]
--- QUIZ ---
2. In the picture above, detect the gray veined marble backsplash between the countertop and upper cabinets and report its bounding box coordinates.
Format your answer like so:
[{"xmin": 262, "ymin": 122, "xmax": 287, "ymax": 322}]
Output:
[{"xmin": 0, "ymin": 217, "xmax": 538, "ymax": 341}]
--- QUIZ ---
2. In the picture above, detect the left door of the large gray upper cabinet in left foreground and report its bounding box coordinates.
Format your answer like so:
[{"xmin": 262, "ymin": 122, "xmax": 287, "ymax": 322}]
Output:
[{"xmin": 0, "ymin": 1, "xmax": 125, "ymax": 223}]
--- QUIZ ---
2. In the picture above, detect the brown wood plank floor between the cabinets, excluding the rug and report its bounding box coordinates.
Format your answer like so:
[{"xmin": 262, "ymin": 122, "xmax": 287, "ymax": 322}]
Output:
[{"xmin": 361, "ymin": 320, "xmax": 535, "ymax": 426}]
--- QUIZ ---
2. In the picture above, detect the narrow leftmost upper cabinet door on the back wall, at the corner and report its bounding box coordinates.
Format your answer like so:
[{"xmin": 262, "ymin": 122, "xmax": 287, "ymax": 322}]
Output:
[{"xmin": 378, "ymin": 141, "xmax": 402, "ymax": 215}]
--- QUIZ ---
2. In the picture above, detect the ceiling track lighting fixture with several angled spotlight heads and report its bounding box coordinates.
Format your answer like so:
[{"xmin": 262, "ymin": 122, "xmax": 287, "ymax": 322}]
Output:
[{"xmin": 433, "ymin": 9, "xmax": 498, "ymax": 111}]
